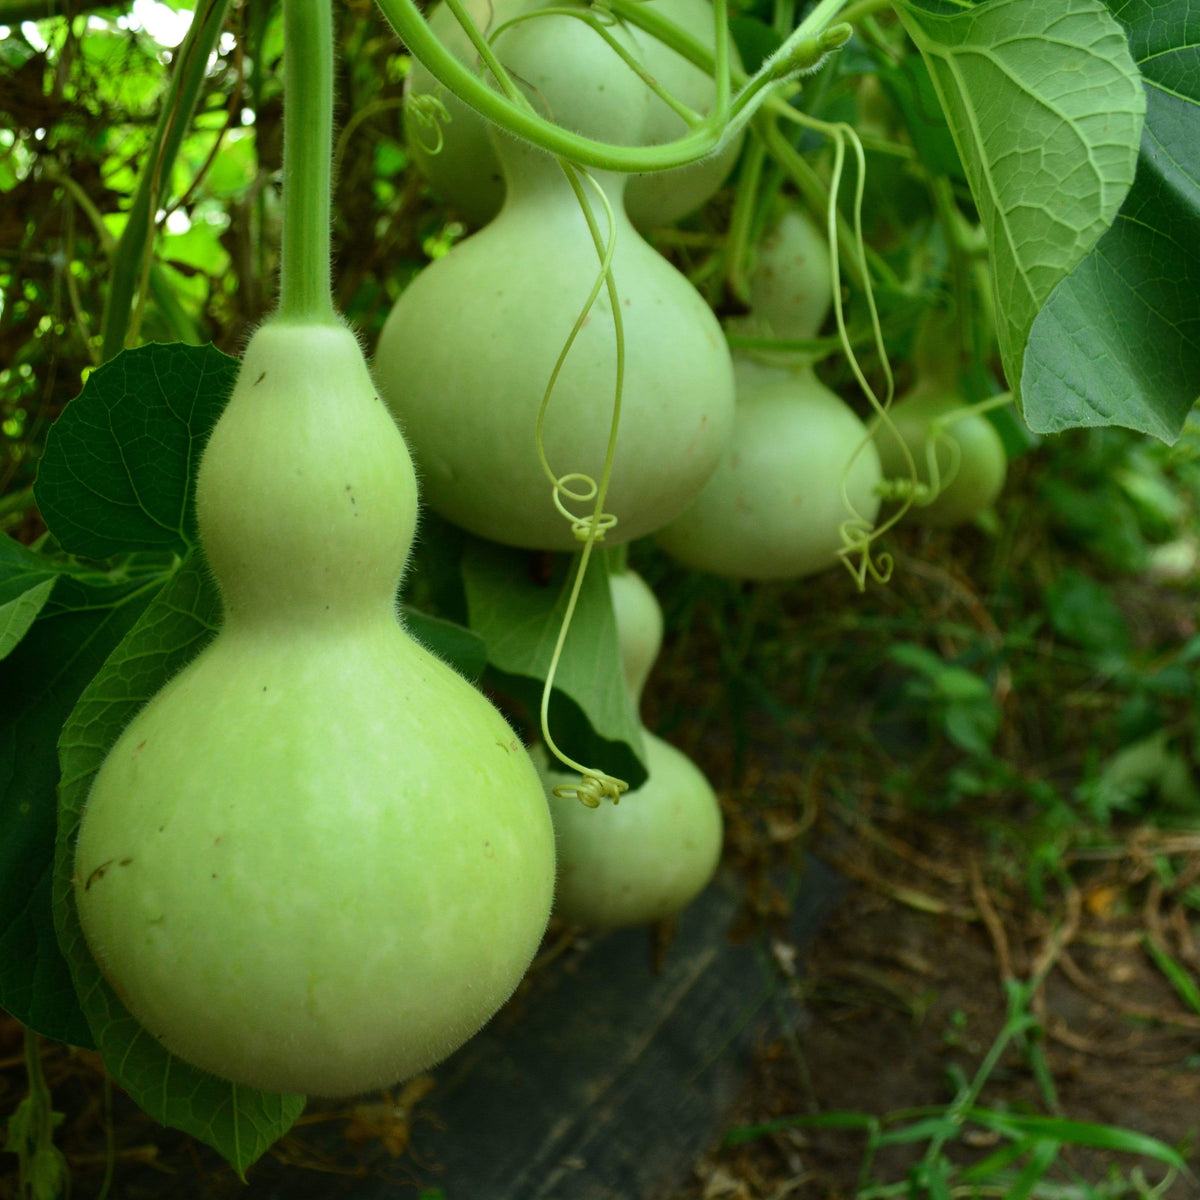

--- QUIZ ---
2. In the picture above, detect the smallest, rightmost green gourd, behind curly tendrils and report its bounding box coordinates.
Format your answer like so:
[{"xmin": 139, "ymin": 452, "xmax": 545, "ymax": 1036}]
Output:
[{"xmin": 875, "ymin": 380, "xmax": 1008, "ymax": 529}]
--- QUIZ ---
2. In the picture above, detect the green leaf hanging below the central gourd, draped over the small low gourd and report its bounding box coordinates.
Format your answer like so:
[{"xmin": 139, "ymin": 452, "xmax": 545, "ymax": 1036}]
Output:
[{"xmin": 462, "ymin": 538, "xmax": 646, "ymax": 788}]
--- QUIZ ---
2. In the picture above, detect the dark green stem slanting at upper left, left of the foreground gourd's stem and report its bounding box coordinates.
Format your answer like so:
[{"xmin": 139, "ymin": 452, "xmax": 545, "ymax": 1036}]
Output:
[{"xmin": 101, "ymin": 0, "xmax": 229, "ymax": 362}]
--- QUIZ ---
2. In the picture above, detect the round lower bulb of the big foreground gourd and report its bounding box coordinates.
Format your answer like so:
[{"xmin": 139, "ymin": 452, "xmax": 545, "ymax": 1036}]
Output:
[{"xmin": 76, "ymin": 616, "xmax": 554, "ymax": 1096}]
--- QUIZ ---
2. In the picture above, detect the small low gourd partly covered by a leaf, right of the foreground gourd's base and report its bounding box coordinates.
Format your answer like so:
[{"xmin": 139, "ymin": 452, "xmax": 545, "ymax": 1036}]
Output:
[{"xmin": 540, "ymin": 570, "xmax": 722, "ymax": 929}]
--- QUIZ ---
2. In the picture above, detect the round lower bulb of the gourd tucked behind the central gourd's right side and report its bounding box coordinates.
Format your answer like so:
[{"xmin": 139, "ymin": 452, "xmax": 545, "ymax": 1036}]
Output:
[{"xmin": 655, "ymin": 358, "xmax": 881, "ymax": 581}]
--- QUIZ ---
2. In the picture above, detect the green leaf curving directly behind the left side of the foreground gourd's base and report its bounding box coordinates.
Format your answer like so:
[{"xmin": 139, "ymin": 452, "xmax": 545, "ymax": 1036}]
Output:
[{"xmin": 54, "ymin": 557, "xmax": 304, "ymax": 1174}]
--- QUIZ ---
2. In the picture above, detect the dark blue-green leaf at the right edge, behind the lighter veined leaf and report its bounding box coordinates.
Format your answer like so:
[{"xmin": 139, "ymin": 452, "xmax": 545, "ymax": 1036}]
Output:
[{"xmin": 1021, "ymin": 0, "xmax": 1200, "ymax": 442}]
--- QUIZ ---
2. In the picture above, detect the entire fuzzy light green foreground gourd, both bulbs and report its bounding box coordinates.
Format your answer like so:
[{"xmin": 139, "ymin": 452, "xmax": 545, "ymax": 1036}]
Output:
[{"xmin": 76, "ymin": 324, "xmax": 554, "ymax": 1096}]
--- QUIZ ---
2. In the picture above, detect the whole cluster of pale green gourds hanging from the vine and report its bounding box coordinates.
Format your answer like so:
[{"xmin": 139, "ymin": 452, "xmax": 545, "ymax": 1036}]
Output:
[{"xmin": 74, "ymin": 0, "xmax": 1008, "ymax": 1096}]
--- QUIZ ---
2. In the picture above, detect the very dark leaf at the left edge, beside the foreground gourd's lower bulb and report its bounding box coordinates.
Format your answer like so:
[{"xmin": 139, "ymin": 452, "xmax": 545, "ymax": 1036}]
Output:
[{"xmin": 0, "ymin": 575, "xmax": 158, "ymax": 1046}]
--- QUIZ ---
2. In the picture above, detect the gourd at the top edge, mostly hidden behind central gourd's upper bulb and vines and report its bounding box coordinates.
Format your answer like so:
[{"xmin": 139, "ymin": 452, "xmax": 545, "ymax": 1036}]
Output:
[{"xmin": 404, "ymin": 0, "xmax": 743, "ymax": 228}]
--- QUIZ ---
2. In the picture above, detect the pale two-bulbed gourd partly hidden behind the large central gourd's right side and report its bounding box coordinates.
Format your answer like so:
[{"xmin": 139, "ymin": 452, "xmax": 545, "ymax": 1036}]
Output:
[{"xmin": 655, "ymin": 209, "xmax": 881, "ymax": 580}]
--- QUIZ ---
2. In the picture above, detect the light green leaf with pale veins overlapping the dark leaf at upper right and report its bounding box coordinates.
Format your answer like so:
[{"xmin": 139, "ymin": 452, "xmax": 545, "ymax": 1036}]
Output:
[{"xmin": 899, "ymin": 0, "xmax": 1146, "ymax": 405}]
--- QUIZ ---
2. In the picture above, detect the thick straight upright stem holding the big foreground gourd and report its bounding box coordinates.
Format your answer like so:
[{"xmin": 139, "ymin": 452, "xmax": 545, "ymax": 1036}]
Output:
[{"xmin": 277, "ymin": 0, "xmax": 338, "ymax": 324}]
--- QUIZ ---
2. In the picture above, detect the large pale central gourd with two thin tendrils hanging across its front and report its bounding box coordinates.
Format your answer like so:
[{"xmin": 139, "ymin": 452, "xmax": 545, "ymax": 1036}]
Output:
[{"xmin": 376, "ymin": 8, "xmax": 733, "ymax": 550}]
